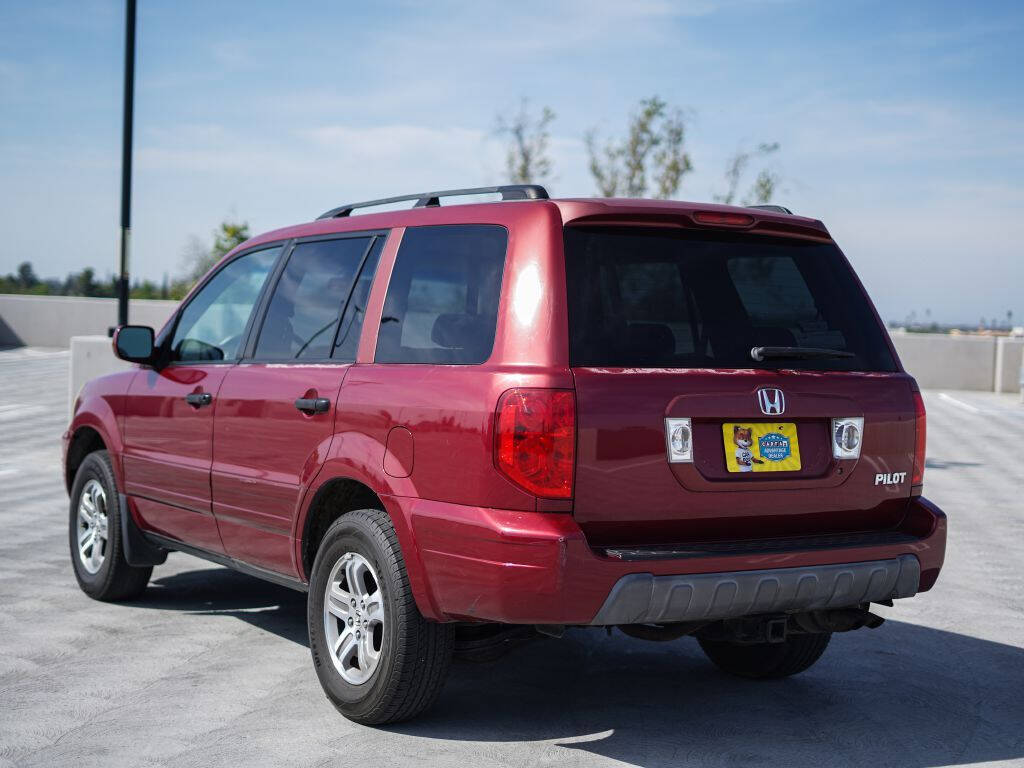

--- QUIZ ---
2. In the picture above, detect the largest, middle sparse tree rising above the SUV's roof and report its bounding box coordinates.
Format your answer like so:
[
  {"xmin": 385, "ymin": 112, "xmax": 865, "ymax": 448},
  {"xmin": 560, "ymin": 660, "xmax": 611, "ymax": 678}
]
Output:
[{"xmin": 586, "ymin": 96, "xmax": 693, "ymax": 198}]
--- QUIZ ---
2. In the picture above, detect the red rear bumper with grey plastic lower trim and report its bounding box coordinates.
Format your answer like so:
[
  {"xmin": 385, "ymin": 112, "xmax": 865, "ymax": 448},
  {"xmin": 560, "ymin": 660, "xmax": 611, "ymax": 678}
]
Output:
[{"xmin": 384, "ymin": 497, "xmax": 946, "ymax": 625}]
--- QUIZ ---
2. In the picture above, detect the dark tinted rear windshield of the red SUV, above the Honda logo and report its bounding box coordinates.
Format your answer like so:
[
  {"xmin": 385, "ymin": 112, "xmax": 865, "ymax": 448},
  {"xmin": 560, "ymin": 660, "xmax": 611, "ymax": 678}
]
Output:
[{"xmin": 565, "ymin": 227, "xmax": 896, "ymax": 371}]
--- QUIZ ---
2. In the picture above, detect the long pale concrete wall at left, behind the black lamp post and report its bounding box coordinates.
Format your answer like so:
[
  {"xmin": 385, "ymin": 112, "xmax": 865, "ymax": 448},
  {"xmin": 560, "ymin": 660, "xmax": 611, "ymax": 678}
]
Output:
[{"xmin": 0, "ymin": 294, "xmax": 178, "ymax": 347}]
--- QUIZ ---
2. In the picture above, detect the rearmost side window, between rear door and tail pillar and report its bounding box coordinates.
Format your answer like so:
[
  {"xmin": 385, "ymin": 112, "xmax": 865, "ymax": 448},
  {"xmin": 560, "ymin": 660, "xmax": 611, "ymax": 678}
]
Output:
[{"xmin": 376, "ymin": 224, "xmax": 508, "ymax": 365}]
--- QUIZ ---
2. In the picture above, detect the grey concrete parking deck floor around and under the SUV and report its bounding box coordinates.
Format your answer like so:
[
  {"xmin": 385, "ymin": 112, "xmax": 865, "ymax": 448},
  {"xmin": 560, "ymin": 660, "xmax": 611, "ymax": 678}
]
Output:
[{"xmin": 0, "ymin": 349, "xmax": 1024, "ymax": 768}]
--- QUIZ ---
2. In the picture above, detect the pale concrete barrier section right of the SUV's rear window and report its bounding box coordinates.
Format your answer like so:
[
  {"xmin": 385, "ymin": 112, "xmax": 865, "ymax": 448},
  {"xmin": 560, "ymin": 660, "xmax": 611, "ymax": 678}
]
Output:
[{"xmin": 892, "ymin": 332, "xmax": 996, "ymax": 392}]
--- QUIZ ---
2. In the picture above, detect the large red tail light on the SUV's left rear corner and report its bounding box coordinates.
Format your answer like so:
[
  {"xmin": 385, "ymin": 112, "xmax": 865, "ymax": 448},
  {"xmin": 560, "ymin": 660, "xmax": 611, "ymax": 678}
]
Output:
[{"xmin": 495, "ymin": 389, "xmax": 575, "ymax": 499}]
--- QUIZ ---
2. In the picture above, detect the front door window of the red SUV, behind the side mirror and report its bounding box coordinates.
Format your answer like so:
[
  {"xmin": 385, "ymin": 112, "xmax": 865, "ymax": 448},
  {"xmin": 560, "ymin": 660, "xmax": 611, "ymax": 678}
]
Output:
[{"xmin": 171, "ymin": 246, "xmax": 281, "ymax": 361}]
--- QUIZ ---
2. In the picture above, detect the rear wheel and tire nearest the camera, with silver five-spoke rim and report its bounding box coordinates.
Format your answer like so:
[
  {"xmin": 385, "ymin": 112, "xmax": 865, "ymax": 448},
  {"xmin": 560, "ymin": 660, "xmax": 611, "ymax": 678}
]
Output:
[{"xmin": 306, "ymin": 509, "xmax": 455, "ymax": 725}]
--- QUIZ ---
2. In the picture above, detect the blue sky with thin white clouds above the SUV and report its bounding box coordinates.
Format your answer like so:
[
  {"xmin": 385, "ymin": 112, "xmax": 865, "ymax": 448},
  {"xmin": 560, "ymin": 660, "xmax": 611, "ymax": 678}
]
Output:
[{"xmin": 0, "ymin": 0, "xmax": 1024, "ymax": 325}]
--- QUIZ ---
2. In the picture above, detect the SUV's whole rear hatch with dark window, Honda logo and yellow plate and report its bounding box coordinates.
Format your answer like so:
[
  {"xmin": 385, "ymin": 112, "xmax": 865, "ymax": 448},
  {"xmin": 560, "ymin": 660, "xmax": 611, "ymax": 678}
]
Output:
[{"xmin": 565, "ymin": 225, "xmax": 915, "ymax": 547}]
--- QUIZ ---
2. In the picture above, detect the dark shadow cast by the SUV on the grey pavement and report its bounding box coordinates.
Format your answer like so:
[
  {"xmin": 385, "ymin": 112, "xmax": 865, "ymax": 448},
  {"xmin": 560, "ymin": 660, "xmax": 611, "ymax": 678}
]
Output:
[{"xmin": 134, "ymin": 568, "xmax": 1024, "ymax": 768}]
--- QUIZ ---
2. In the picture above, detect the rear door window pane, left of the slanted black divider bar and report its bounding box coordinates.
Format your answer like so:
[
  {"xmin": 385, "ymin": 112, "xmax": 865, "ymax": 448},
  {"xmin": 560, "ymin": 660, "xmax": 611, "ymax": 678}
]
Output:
[{"xmin": 255, "ymin": 238, "xmax": 370, "ymax": 360}]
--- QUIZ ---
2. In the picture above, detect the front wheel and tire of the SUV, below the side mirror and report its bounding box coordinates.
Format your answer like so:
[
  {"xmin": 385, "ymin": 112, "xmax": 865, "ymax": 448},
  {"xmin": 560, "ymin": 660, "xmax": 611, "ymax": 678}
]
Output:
[{"xmin": 68, "ymin": 451, "xmax": 153, "ymax": 602}]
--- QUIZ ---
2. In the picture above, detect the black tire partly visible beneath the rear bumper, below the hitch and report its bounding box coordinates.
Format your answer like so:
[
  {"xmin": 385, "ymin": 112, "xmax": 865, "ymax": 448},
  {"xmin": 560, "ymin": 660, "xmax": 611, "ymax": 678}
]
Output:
[{"xmin": 698, "ymin": 632, "xmax": 831, "ymax": 680}]
